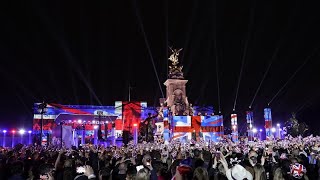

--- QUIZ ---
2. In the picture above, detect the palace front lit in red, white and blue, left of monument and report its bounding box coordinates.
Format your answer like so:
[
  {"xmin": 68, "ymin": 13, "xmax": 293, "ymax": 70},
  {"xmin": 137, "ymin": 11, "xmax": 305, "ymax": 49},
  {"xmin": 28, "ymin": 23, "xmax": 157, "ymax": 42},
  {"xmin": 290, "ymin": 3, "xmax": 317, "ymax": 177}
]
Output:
[{"xmin": 33, "ymin": 101, "xmax": 156, "ymax": 145}]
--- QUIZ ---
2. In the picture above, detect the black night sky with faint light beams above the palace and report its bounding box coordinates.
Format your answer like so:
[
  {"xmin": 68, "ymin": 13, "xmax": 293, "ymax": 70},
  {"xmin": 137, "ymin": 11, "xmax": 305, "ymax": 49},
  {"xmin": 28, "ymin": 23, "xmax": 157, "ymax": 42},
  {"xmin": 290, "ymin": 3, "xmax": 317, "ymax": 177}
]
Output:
[{"xmin": 0, "ymin": 0, "xmax": 320, "ymax": 134}]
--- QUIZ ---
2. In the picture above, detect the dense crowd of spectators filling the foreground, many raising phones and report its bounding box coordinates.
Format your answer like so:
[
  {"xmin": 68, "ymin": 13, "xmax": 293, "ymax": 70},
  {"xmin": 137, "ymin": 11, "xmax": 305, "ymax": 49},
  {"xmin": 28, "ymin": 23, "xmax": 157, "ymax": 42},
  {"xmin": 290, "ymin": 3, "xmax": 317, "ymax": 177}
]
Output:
[{"xmin": 0, "ymin": 136, "xmax": 320, "ymax": 180}]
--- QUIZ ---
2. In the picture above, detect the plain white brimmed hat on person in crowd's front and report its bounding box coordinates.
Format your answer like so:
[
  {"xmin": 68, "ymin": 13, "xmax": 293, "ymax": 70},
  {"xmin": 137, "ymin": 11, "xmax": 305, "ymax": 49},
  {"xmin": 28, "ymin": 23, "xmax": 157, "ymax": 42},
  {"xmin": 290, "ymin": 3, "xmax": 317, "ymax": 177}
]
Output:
[{"xmin": 226, "ymin": 164, "xmax": 253, "ymax": 180}]
